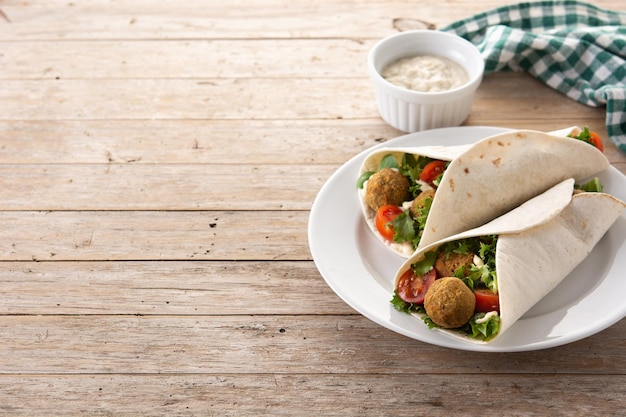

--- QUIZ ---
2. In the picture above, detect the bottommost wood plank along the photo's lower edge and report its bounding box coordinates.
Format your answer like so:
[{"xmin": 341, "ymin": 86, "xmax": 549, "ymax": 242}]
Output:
[{"xmin": 0, "ymin": 374, "xmax": 626, "ymax": 417}]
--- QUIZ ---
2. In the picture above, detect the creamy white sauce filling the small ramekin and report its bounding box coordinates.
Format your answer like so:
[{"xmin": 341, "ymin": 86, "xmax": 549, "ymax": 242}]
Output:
[{"xmin": 381, "ymin": 55, "xmax": 469, "ymax": 93}]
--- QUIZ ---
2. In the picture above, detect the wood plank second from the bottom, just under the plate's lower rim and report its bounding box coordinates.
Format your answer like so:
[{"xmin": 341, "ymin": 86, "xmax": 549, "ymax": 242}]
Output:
[{"xmin": 0, "ymin": 310, "xmax": 626, "ymax": 381}]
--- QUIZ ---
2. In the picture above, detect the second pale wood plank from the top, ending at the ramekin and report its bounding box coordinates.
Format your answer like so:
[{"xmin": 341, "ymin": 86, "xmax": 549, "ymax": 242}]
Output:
[{"xmin": 0, "ymin": 39, "xmax": 375, "ymax": 80}]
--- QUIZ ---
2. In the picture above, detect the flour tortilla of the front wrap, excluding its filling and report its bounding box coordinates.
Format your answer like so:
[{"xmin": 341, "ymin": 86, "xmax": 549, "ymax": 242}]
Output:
[{"xmin": 394, "ymin": 179, "xmax": 626, "ymax": 343}]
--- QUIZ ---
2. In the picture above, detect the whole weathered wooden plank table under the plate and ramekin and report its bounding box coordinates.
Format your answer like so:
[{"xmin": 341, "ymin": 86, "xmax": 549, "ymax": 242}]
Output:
[{"xmin": 0, "ymin": 0, "xmax": 626, "ymax": 416}]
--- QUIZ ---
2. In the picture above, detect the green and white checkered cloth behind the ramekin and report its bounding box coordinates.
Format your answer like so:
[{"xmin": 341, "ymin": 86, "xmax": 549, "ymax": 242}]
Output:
[{"xmin": 441, "ymin": 0, "xmax": 626, "ymax": 152}]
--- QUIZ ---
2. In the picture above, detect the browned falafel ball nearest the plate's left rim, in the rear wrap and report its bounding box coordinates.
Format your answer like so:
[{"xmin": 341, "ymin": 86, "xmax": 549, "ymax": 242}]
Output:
[{"xmin": 365, "ymin": 168, "xmax": 411, "ymax": 211}]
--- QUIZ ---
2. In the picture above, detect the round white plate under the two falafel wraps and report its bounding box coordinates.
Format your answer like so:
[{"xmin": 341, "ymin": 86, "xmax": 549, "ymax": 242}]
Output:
[{"xmin": 308, "ymin": 127, "xmax": 626, "ymax": 352}]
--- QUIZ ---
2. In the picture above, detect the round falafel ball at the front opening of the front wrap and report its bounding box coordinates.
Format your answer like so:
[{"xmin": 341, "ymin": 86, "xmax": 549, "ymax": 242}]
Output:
[{"xmin": 424, "ymin": 277, "xmax": 476, "ymax": 329}]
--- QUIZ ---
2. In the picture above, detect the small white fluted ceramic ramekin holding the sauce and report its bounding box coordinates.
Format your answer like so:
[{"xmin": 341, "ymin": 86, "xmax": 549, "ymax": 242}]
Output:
[{"xmin": 368, "ymin": 30, "xmax": 485, "ymax": 132}]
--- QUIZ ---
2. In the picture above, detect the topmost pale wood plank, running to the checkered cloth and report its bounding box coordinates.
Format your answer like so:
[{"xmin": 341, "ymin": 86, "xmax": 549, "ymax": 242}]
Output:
[{"xmin": 0, "ymin": 0, "xmax": 615, "ymax": 40}]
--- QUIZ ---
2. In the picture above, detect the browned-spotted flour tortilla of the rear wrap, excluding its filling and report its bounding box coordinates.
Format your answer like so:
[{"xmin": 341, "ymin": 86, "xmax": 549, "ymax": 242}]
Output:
[{"xmin": 359, "ymin": 126, "xmax": 609, "ymax": 258}]
